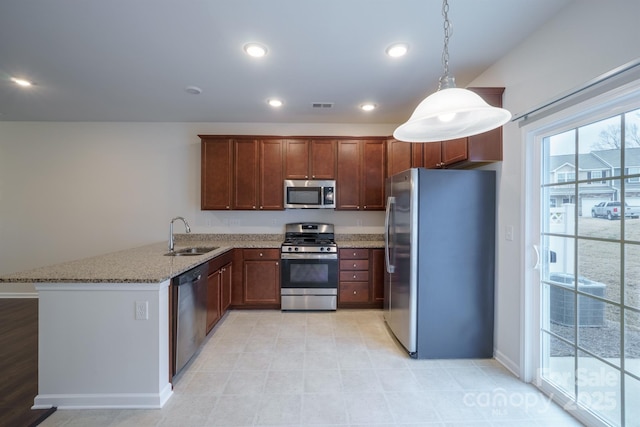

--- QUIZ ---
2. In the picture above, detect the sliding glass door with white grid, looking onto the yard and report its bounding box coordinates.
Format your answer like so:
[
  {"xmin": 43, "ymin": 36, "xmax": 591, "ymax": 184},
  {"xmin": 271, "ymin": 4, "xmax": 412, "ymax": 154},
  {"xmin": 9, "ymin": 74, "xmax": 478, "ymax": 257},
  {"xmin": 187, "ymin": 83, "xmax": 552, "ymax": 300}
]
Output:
[{"xmin": 538, "ymin": 106, "xmax": 640, "ymax": 427}]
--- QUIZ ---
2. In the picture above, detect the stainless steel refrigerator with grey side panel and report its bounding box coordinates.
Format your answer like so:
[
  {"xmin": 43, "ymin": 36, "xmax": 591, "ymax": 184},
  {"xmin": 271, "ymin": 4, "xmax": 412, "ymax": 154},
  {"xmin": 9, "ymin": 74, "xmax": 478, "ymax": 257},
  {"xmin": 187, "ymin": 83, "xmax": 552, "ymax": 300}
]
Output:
[{"xmin": 384, "ymin": 168, "xmax": 496, "ymax": 359}]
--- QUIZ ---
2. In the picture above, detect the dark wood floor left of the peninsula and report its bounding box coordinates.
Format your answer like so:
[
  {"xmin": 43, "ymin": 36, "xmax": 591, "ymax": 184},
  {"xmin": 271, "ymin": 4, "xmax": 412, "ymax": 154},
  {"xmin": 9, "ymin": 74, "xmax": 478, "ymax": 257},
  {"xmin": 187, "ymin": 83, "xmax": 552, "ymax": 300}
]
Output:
[{"xmin": 0, "ymin": 298, "xmax": 55, "ymax": 427}]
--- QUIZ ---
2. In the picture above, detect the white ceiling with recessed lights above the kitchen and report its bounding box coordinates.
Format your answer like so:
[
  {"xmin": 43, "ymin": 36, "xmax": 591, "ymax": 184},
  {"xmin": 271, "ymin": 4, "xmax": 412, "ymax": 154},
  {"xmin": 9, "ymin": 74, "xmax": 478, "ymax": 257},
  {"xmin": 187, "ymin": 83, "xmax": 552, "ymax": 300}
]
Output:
[{"xmin": 0, "ymin": 0, "xmax": 572, "ymax": 123}]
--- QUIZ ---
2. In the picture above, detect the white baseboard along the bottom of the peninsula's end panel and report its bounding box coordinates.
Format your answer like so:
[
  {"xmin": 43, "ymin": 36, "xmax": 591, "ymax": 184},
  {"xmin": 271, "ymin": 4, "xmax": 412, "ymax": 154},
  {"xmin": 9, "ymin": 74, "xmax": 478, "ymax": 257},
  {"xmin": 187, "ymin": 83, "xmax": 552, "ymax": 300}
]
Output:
[{"xmin": 31, "ymin": 384, "xmax": 173, "ymax": 409}]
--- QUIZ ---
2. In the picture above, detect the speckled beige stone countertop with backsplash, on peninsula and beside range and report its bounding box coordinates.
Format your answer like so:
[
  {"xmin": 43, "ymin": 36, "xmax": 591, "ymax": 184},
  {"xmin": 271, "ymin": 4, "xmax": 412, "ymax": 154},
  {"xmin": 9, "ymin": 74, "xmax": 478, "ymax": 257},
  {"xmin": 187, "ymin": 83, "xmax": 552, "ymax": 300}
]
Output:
[{"xmin": 0, "ymin": 234, "xmax": 384, "ymax": 283}]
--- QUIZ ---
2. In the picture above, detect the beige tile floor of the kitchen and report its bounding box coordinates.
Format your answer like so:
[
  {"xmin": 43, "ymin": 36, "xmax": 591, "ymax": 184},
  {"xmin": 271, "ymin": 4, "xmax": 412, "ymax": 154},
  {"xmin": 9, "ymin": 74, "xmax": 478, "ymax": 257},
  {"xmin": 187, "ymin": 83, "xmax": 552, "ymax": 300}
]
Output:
[{"xmin": 41, "ymin": 310, "xmax": 581, "ymax": 427}]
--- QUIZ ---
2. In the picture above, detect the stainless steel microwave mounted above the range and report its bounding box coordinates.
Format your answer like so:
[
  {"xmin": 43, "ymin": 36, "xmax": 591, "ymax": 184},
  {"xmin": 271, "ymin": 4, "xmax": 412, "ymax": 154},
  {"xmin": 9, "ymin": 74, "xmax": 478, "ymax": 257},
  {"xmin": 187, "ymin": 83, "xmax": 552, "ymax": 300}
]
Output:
[{"xmin": 284, "ymin": 179, "xmax": 336, "ymax": 209}]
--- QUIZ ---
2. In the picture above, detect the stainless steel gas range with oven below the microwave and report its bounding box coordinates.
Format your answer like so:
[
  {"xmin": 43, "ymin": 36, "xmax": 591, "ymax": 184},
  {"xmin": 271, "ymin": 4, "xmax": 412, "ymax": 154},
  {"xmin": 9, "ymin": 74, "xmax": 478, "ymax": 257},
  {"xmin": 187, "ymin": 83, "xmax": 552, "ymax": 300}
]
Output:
[{"xmin": 280, "ymin": 222, "xmax": 338, "ymax": 310}]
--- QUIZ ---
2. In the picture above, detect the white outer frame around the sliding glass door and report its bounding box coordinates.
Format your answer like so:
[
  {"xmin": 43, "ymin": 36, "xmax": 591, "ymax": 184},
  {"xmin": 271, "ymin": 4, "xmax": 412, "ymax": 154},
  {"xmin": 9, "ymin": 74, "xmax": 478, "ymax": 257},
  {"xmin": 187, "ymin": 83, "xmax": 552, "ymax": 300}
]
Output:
[{"xmin": 520, "ymin": 77, "xmax": 640, "ymax": 426}]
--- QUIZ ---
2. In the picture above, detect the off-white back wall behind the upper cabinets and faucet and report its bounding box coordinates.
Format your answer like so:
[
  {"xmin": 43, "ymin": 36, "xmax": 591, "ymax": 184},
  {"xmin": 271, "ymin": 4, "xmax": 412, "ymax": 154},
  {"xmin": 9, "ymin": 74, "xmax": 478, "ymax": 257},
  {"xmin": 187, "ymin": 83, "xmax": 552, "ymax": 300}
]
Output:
[{"xmin": 0, "ymin": 122, "xmax": 394, "ymax": 274}]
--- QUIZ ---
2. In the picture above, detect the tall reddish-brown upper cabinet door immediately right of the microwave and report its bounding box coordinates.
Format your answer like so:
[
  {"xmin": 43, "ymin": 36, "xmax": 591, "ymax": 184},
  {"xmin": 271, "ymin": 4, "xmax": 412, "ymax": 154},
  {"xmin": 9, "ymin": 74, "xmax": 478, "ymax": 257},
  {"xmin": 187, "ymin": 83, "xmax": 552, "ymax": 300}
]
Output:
[{"xmin": 336, "ymin": 140, "xmax": 360, "ymax": 210}]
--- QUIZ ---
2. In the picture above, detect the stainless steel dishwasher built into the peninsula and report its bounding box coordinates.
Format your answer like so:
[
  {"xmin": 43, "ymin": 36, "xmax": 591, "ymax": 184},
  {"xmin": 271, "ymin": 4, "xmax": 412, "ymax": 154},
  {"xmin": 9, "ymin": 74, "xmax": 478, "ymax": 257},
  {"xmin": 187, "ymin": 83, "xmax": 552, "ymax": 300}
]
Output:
[{"xmin": 174, "ymin": 263, "xmax": 209, "ymax": 374}]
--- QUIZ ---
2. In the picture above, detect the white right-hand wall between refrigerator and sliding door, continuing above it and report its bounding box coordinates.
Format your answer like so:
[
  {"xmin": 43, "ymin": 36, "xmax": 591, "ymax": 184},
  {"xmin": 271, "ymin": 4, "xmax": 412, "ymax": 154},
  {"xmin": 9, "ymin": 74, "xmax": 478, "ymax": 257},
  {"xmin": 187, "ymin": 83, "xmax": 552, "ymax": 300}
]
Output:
[{"xmin": 470, "ymin": 0, "xmax": 640, "ymax": 373}]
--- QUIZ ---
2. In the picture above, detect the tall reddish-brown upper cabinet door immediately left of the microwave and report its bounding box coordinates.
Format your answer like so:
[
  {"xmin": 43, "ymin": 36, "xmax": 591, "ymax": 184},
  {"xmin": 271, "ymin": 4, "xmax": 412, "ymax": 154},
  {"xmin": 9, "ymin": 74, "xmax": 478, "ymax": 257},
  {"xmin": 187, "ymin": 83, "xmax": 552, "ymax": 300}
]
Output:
[{"xmin": 259, "ymin": 139, "xmax": 284, "ymax": 210}]
